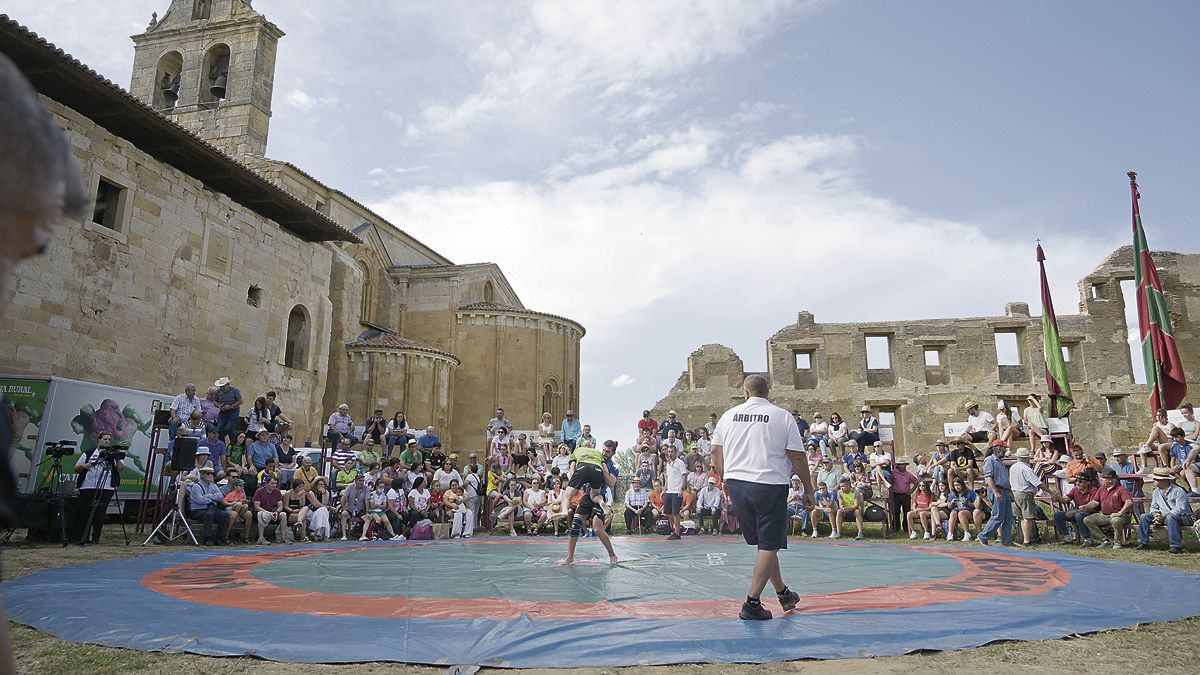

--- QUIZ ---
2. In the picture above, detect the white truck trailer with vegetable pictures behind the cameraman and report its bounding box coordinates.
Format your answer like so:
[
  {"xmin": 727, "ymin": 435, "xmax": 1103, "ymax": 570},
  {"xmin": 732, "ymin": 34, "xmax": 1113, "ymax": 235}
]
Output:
[{"xmin": 0, "ymin": 376, "xmax": 173, "ymax": 503}]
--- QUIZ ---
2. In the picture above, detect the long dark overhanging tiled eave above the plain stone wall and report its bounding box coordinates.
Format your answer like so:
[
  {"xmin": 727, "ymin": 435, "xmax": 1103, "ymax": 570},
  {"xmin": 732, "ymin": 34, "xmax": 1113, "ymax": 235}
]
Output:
[{"xmin": 0, "ymin": 14, "xmax": 359, "ymax": 243}]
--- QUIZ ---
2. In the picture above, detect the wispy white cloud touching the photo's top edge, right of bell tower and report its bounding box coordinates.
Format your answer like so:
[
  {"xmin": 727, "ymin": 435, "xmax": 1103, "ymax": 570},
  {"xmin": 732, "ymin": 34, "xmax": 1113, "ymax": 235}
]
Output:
[{"xmin": 409, "ymin": 0, "xmax": 821, "ymax": 139}]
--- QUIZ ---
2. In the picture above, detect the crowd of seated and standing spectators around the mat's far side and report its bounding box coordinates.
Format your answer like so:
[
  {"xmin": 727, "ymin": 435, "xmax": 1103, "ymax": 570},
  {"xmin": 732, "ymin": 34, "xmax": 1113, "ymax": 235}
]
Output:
[{"xmin": 162, "ymin": 378, "xmax": 1200, "ymax": 552}]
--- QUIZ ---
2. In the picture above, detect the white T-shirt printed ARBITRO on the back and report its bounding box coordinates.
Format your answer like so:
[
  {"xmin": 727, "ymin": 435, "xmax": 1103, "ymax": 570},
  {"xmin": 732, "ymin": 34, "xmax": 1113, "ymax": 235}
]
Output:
[{"xmin": 713, "ymin": 396, "xmax": 804, "ymax": 485}]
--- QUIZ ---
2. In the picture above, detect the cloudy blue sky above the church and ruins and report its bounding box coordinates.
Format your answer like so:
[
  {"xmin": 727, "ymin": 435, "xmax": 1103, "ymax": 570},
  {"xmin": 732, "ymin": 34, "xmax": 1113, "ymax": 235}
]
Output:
[{"xmin": 7, "ymin": 0, "xmax": 1200, "ymax": 443}]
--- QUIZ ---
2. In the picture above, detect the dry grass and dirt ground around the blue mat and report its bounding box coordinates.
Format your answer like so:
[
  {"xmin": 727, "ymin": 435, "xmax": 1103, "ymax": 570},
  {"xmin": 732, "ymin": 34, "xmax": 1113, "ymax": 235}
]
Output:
[{"xmin": 0, "ymin": 526, "xmax": 1200, "ymax": 675}]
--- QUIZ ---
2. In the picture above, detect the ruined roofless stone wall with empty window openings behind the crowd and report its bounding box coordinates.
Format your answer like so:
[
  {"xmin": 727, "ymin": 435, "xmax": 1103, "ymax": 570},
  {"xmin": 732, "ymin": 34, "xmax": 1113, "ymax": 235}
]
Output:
[{"xmin": 652, "ymin": 247, "xmax": 1200, "ymax": 454}]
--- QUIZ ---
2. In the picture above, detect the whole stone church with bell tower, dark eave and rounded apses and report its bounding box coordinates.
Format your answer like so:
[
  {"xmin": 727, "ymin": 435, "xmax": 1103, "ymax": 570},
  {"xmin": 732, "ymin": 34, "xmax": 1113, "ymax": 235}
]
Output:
[{"xmin": 0, "ymin": 0, "xmax": 584, "ymax": 447}]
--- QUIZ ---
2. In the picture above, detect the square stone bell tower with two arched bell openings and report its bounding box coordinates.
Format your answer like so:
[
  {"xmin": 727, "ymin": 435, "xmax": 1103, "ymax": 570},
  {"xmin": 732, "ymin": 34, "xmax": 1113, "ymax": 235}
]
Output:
[{"xmin": 130, "ymin": 0, "xmax": 283, "ymax": 156}]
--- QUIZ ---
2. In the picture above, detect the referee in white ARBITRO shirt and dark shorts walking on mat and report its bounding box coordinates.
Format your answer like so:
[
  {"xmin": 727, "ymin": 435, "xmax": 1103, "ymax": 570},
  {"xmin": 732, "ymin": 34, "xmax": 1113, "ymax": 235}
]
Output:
[{"xmin": 712, "ymin": 375, "xmax": 812, "ymax": 621}]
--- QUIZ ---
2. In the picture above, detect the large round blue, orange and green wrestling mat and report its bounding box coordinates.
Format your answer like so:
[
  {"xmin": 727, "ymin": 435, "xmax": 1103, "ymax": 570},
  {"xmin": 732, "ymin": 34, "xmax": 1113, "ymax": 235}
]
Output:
[{"xmin": 0, "ymin": 537, "xmax": 1200, "ymax": 668}]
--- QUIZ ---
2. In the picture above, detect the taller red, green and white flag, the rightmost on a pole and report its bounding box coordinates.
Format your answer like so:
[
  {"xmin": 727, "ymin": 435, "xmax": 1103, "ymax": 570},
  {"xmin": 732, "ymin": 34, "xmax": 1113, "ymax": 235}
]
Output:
[{"xmin": 1128, "ymin": 172, "xmax": 1188, "ymax": 412}]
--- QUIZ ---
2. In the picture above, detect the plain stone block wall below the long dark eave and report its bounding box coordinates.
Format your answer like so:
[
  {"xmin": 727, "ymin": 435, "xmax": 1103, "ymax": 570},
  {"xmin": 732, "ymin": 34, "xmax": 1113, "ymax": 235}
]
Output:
[{"xmin": 0, "ymin": 100, "xmax": 332, "ymax": 438}]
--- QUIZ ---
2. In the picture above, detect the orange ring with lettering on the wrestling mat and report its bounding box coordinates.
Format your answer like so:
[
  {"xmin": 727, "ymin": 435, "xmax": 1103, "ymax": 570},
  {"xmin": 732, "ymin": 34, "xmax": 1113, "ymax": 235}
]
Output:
[{"xmin": 142, "ymin": 540, "xmax": 1070, "ymax": 620}]
